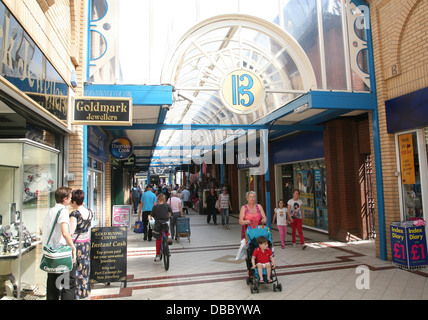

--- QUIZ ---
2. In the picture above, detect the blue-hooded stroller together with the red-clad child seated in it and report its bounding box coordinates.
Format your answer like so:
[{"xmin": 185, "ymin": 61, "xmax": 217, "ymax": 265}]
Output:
[{"xmin": 246, "ymin": 226, "xmax": 282, "ymax": 293}]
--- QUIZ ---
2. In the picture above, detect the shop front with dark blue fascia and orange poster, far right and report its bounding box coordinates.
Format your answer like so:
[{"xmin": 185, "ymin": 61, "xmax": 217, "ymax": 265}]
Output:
[{"xmin": 385, "ymin": 88, "xmax": 428, "ymax": 221}]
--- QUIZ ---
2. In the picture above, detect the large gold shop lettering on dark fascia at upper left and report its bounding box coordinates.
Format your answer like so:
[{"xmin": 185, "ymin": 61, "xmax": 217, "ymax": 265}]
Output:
[{"xmin": 0, "ymin": 15, "xmax": 67, "ymax": 115}]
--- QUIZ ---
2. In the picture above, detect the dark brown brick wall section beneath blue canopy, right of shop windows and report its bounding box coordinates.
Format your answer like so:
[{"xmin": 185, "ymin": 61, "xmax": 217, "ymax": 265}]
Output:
[{"xmin": 324, "ymin": 118, "xmax": 369, "ymax": 241}]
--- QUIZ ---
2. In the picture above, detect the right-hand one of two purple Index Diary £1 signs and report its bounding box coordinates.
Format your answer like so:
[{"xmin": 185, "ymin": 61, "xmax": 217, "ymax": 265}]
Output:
[{"xmin": 406, "ymin": 227, "xmax": 428, "ymax": 267}]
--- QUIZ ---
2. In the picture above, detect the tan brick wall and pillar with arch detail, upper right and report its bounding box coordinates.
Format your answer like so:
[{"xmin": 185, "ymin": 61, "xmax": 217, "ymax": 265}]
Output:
[{"xmin": 368, "ymin": 0, "xmax": 428, "ymax": 259}]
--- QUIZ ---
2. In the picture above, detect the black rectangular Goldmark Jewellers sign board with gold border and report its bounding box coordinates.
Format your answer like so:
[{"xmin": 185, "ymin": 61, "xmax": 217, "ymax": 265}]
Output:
[{"xmin": 73, "ymin": 97, "xmax": 132, "ymax": 126}]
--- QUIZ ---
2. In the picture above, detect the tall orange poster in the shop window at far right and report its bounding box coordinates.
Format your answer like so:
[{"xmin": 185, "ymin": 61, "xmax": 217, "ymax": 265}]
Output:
[{"xmin": 398, "ymin": 133, "xmax": 416, "ymax": 184}]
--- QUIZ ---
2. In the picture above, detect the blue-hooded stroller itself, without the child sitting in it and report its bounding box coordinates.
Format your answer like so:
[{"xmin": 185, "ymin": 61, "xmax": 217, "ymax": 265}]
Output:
[{"xmin": 246, "ymin": 226, "xmax": 282, "ymax": 293}]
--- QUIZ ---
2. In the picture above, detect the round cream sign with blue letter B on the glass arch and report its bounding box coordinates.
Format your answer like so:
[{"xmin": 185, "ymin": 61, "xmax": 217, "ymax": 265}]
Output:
[{"xmin": 220, "ymin": 69, "xmax": 266, "ymax": 114}]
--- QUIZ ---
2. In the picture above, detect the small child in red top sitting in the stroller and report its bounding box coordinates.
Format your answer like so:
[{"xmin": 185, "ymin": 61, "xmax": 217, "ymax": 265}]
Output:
[{"xmin": 251, "ymin": 236, "xmax": 275, "ymax": 283}]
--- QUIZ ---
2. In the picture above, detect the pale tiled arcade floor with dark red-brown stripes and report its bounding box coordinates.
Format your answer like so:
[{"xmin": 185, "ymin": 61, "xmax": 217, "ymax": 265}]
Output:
[{"xmin": 91, "ymin": 212, "xmax": 428, "ymax": 300}]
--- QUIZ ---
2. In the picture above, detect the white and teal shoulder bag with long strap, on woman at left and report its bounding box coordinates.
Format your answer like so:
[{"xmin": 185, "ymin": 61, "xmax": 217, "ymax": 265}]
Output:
[{"xmin": 40, "ymin": 208, "xmax": 73, "ymax": 273}]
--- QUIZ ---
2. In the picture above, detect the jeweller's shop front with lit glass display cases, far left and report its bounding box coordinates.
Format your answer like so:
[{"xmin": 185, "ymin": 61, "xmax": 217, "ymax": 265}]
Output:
[{"xmin": 0, "ymin": 2, "xmax": 72, "ymax": 297}]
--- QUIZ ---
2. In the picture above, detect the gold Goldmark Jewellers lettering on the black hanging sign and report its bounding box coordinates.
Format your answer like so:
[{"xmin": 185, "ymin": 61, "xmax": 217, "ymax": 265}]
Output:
[{"xmin": 76, "ymin": 101, "xmax": 129, "ymax": 121}]
